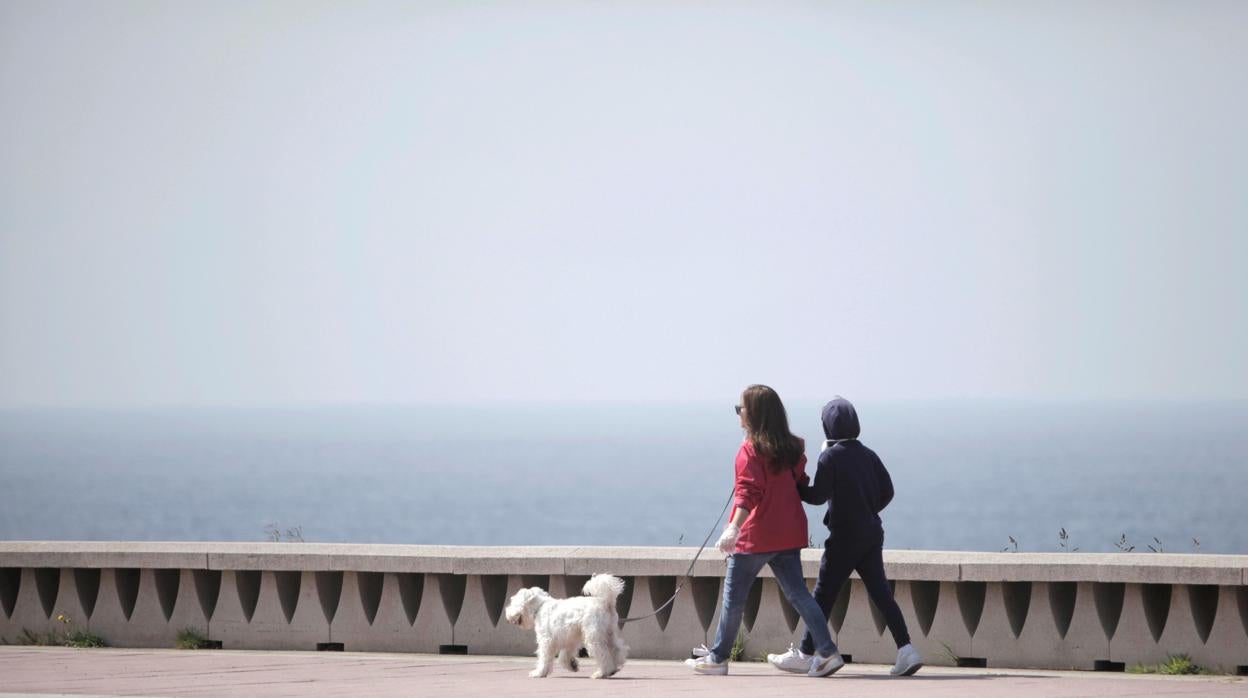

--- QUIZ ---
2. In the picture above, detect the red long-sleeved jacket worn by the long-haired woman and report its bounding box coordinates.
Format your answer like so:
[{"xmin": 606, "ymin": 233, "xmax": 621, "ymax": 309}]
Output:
[{"xmin": 733, "ymin": 438, "xmax": 810, "ymax": 553}]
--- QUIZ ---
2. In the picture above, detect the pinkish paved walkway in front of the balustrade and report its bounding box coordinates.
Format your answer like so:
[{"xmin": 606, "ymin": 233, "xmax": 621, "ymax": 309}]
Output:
[{"xmin": 0, "ymin": 646, "xmax": 1248, "ymax": 698}]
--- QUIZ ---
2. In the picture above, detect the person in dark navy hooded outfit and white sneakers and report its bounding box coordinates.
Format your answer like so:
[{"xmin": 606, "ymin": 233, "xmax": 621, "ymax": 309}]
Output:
[{"xmin": 768, "ymin": 396, "xmax": 924, "ymax": 676}]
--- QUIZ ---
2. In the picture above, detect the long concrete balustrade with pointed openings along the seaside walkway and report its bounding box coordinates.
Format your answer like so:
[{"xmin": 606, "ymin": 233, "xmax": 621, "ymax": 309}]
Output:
[{"xmin": 0, "ymin": 542, "xmax": 1248, "ymax": 673}]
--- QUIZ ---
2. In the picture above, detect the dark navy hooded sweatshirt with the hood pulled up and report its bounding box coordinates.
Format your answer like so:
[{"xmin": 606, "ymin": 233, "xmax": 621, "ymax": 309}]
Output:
[{"xmin": 797, "ymin": 397, "xmax": 892, "ymax": 541}]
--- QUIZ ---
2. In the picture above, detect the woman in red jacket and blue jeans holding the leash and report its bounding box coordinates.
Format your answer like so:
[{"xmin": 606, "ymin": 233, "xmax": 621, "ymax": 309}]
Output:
[{"xmin": 685, "ymin": 386, "xmax": 845, "ymax": 677}]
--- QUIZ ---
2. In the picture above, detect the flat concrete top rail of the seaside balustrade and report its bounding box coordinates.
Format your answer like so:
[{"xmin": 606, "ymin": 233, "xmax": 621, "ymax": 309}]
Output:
[{"xmin": 0, "ymin": 541, "xmax": 1248, "ymax": 584}]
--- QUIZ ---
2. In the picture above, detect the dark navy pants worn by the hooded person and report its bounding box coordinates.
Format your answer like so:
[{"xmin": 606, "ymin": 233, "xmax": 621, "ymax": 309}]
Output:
[{"xmin": 801, "ymin": 532, "xmax": 910, "ymax": 654}]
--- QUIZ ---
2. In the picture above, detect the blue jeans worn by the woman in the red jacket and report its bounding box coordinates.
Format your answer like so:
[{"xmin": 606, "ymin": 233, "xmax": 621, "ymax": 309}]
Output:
[{"xmin": 710, "ymin": 549, "xmax": 836, "ymax": 663}]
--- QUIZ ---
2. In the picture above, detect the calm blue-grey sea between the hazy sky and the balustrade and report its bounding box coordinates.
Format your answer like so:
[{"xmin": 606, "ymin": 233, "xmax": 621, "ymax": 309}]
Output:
[{"xmin": 0, "ymin": 402, "xmax": 1248, "ymax": 553}]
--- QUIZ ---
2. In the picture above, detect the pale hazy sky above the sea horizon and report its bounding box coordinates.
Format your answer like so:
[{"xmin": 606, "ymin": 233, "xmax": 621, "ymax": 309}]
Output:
[{"xmin": 0, "ymin": 0, "xmax": 1248, "ymax": 406}]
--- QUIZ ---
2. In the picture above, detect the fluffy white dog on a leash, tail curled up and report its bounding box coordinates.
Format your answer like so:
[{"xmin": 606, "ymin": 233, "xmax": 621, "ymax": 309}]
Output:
[{"xmin": 507, "ymin": 574, "xmax": 628, "ymax": 678}]
